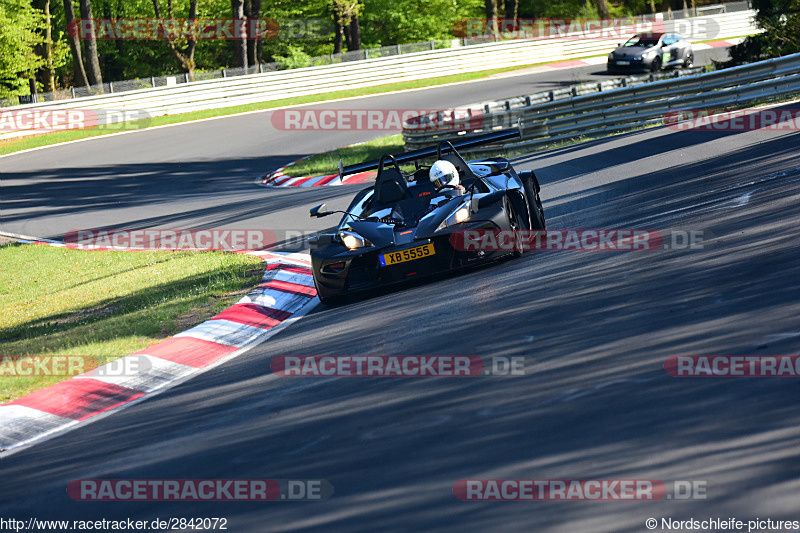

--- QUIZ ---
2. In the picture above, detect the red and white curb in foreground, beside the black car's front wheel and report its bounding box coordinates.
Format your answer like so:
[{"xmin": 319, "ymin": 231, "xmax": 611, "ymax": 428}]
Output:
[{"xmin": 0, "ymin": 240, "xmax": 319, "ymax": 456}]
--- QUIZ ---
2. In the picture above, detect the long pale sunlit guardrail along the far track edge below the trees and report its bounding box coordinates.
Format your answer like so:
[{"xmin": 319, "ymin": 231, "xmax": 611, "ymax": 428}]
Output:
[{"xmin": 0, "ymin": 11, "xmax": 757, "ymax": 139}]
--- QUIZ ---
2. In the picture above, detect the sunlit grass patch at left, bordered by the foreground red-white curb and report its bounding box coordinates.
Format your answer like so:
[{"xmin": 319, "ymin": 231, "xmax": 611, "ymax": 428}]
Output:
[{"xmin": 0, "ymin": 244, "xmax": 263, "ymax": 403}]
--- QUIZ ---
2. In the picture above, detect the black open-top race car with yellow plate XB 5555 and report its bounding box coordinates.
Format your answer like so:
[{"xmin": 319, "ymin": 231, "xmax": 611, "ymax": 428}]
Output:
[{"xmin": 309, "ymin": 130, "xmax": 545, "ymax": 305}]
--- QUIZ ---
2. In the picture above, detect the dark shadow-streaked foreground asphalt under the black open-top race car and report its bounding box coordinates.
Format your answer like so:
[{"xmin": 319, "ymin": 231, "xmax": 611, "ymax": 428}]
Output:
[{"xmin": 0, "ymin": 47, "xmax": 800, "ymax": 532}]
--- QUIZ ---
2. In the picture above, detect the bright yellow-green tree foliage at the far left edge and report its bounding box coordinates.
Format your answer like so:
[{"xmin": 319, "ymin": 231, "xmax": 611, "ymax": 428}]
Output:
[{"xmin": 0, "ymin": 0, "xmax": 47, "ymax": 98}]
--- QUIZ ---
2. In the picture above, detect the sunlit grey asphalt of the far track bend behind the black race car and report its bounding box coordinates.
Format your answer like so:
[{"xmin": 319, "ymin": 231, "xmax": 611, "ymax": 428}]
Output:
[{"xmin": 0, "ymin": 49, "xmax": 727, "ymax": 238}]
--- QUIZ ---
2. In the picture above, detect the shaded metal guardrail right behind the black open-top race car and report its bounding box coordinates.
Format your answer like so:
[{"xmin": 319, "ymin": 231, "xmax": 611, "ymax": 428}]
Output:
[{"xmin": 404, "ymin": 54, "xmax": 800, "ymax": 154}]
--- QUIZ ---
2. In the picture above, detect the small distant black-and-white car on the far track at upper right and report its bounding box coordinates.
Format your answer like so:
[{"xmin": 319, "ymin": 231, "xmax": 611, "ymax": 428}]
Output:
[{"xmin": 607, "ymin": 33, "xmax": 694, "ymax": 72}]
